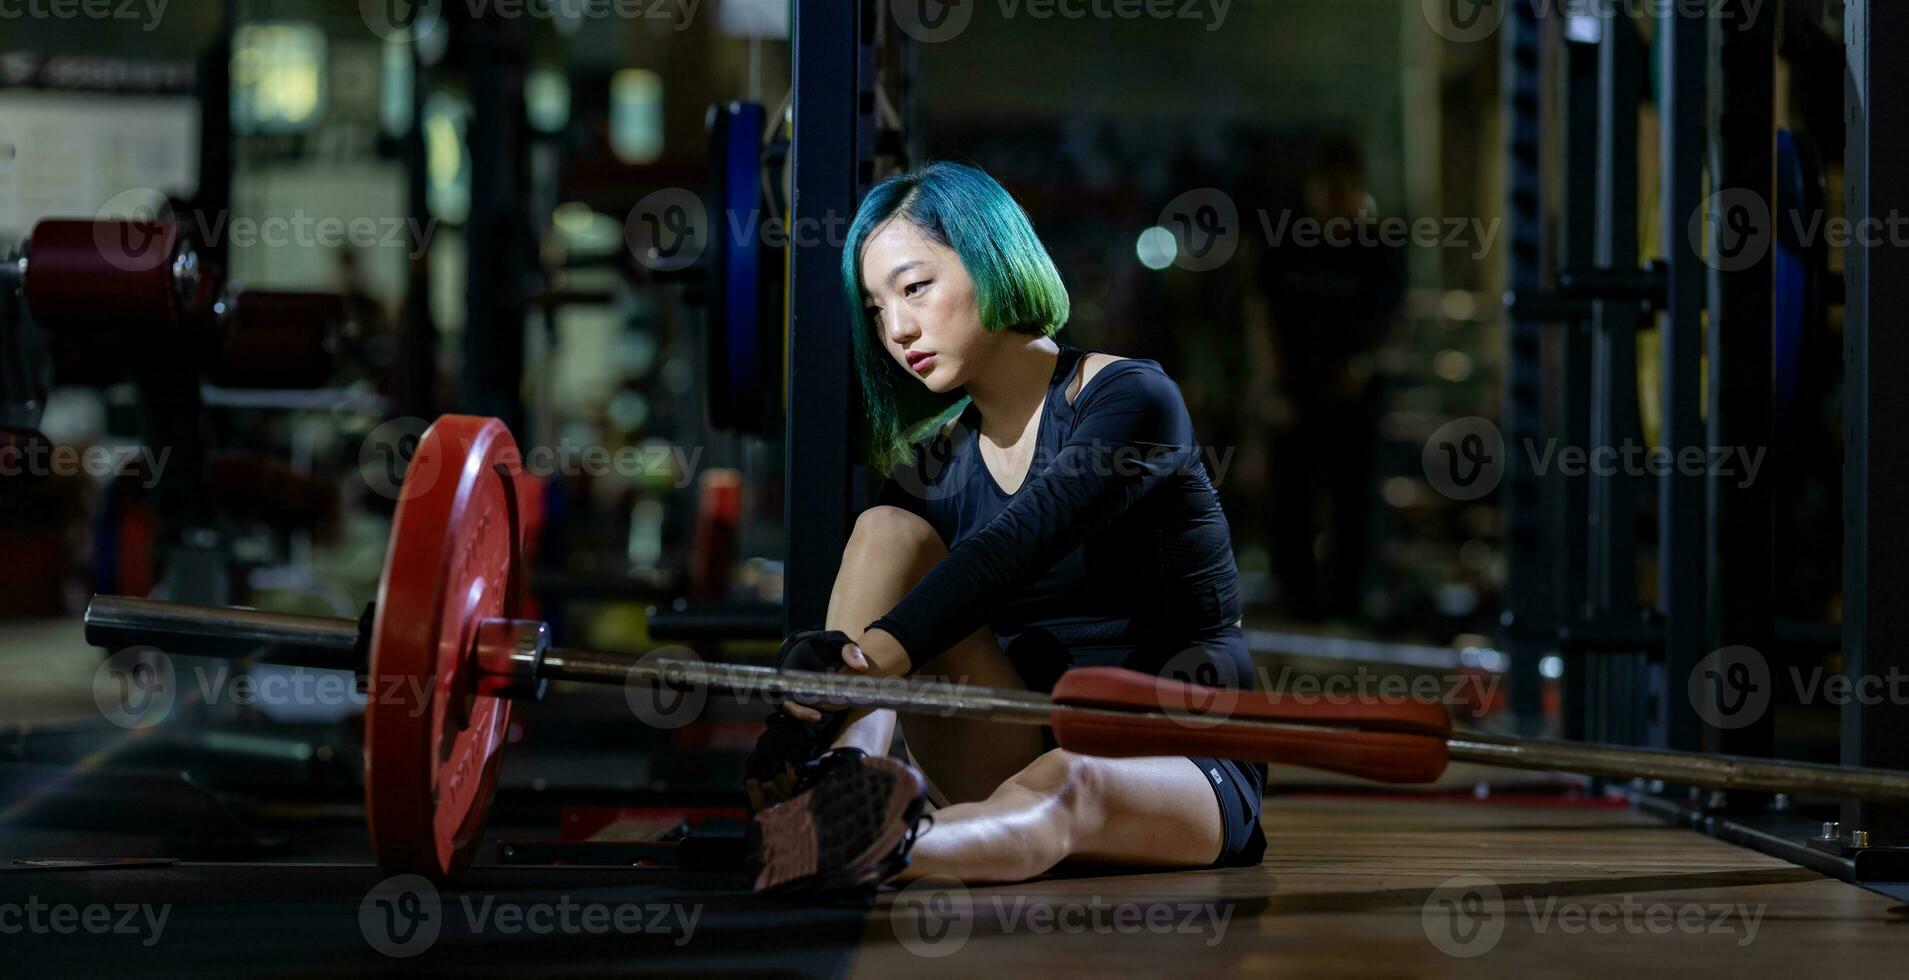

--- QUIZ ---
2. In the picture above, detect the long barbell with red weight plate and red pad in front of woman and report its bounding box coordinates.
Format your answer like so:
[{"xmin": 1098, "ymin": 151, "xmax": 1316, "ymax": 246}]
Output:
[{"xmin": 86, "ymin": 415, "xmax": 1909, "ymax": 879}]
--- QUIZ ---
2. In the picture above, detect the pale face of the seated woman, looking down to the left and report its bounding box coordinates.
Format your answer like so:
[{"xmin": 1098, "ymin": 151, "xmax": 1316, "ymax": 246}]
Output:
[{"xmin": 861, "ymin": 218, "xmax": 996, "ymax": 394}]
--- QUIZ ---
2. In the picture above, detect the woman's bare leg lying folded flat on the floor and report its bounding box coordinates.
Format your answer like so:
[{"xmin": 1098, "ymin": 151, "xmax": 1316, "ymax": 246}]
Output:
[{"xmin": 897, "ymin": 749, "xmax": 1226, "ymax": 884}]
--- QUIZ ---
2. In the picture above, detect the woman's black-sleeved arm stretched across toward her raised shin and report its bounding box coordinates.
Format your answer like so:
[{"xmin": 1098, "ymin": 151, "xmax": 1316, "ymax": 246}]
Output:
[{"xmin": 863, "ymin": 361, "xmax": 1199, "ymax": 671}]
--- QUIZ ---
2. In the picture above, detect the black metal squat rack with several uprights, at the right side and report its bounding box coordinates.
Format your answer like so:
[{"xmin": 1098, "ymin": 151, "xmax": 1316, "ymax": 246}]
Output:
[{"xmin": 1502, "ymin": 0, "xmax": 1909, "ymax": 877}]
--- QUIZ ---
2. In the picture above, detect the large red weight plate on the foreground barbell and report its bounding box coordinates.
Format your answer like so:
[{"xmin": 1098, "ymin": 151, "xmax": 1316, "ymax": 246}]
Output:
[{"xmin": 365, "ymin": 415, "xmax": 521, "ymax": 879}]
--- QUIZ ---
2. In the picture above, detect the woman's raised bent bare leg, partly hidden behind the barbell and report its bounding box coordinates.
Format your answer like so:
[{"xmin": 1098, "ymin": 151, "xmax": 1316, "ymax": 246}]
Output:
[{"xmin": 827, "ymin": 506, "xmax": 1042, "ymax": 800}]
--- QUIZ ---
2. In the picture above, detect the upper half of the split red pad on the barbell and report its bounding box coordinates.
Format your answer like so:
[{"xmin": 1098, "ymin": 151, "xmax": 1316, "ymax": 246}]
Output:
[{"xmin": 1052, "ymin": 667, "xmax": 1451, "ymax": 739}]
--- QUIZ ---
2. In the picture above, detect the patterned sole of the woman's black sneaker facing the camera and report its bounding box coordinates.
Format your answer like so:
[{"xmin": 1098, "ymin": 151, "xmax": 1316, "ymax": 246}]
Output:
[{"xmin": 752, "ymin": 758, "xmax": 922, "ymax": 892}]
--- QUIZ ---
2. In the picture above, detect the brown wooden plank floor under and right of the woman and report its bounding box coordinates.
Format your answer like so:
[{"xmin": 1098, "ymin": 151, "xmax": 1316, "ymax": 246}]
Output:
[{"xmin": 851, "ymin": 797, "xmax": 1909, "ymax": 980}]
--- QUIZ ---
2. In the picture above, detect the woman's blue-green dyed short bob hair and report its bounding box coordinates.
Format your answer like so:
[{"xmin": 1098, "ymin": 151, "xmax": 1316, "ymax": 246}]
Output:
[{"xmin": 842, "ymin": 160, "xmax": 1069, "ymax": 476}]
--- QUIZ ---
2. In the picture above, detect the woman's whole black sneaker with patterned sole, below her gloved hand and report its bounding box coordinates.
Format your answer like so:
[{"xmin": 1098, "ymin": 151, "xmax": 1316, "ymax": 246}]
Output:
[{"xmin": 746, "ymin": 747, "xmax": 934, "ymax": 892}]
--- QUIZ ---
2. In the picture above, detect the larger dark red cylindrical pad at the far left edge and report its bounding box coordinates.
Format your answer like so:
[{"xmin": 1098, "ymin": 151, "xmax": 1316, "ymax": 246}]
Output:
[{"xmin": 21, "ymin": 220, "xmax": 179, "ymax": 330}]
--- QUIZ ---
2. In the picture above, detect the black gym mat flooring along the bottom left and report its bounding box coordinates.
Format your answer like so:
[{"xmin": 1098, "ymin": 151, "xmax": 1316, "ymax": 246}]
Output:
[{"xmin": 0, "ymin": 862, "xmax": 872, "ymax": 978}]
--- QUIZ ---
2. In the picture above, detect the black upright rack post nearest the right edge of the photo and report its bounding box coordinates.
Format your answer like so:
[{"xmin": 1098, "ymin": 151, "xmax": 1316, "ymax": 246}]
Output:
[{"xmin": 1842, "ymin": 0, "xmax": 1909, "ymax": 841}]
